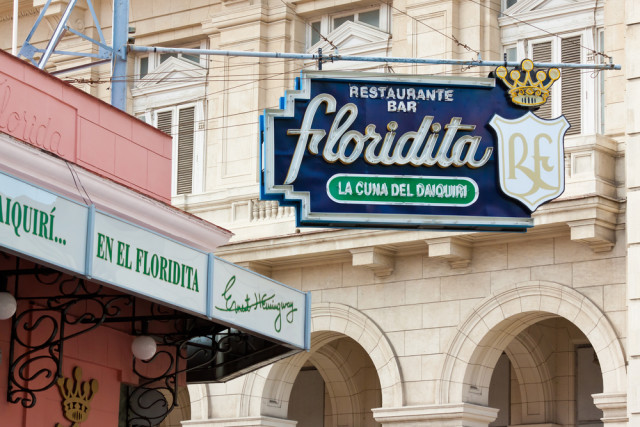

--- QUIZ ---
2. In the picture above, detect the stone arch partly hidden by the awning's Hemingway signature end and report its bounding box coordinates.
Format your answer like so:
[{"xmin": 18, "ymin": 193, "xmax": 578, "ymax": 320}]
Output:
[{"xmin": 256, "ymin": 303, "xmax": 403, "ymax": 427}]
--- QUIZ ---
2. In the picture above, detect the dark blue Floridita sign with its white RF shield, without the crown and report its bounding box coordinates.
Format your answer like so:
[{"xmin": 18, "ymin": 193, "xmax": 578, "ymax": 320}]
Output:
[{"xmin": 261, "ymin": 72, "xmax": 568, "ymax": 230}]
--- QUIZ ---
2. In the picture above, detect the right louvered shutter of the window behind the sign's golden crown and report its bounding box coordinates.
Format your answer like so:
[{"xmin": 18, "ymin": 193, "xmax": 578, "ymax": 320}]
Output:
[{"xmin": 560, "ymin": 36, "xmax": 582, "ymax": 135}]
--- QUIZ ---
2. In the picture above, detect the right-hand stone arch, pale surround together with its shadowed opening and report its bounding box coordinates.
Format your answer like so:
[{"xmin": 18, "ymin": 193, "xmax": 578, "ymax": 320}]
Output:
[{"xmin": 439, "ymin": 282, "xmax": 626, "ymax": 426}]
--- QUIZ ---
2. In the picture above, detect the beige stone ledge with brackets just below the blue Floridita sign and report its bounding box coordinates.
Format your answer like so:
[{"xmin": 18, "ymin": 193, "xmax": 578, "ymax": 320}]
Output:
[{"xmin": 216, "ymin": 195, "xmax": 624, "ymax": 268}]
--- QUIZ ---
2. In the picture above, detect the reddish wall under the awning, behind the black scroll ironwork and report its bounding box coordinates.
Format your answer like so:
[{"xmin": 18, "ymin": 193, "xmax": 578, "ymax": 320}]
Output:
[{"xmin": 0, "ymin": 254, "xmax": 186, "ymax": 427}]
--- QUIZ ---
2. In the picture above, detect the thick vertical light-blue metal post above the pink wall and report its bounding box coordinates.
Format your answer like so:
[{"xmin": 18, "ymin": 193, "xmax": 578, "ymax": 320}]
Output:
[{"xmin": 111, "ymin": 0, "xmax": 129, "ymax": 111}]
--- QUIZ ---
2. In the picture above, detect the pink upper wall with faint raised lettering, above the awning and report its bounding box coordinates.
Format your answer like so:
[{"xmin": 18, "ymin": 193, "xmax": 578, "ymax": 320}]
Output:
[{"xmin": 0, "ymin": 51, "xmax": 171, "ymax": 203}]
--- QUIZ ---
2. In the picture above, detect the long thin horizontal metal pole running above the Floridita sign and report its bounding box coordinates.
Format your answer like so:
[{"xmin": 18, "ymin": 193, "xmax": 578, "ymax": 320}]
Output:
[{"xmin": 129, "ymin": 45, "xmax": 620, "ymax": 70}]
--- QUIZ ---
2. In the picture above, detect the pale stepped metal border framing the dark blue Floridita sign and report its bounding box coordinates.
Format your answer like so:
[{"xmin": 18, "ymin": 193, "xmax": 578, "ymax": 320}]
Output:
[{"xmin": 260, "ymin": 71, "xmax": 544, "ymax": 231}]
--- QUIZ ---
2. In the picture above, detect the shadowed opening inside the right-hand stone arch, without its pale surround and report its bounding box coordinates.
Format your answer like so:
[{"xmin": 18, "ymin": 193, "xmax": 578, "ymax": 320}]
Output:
[{"xmin": 489, "ymin": 317, "xmax": 603, "ymax": 427}]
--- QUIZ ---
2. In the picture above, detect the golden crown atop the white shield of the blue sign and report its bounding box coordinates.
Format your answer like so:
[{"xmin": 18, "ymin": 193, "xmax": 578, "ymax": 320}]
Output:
[{"xmin": 496, "ymin": 59, "xmax": 560, "ymax": 107}]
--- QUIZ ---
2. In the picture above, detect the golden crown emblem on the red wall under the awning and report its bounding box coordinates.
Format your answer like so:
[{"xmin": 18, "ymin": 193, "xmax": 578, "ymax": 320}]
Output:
[{"xmin": 58, "ymin": 366, "xmax": 98, "ymax": 427}]
